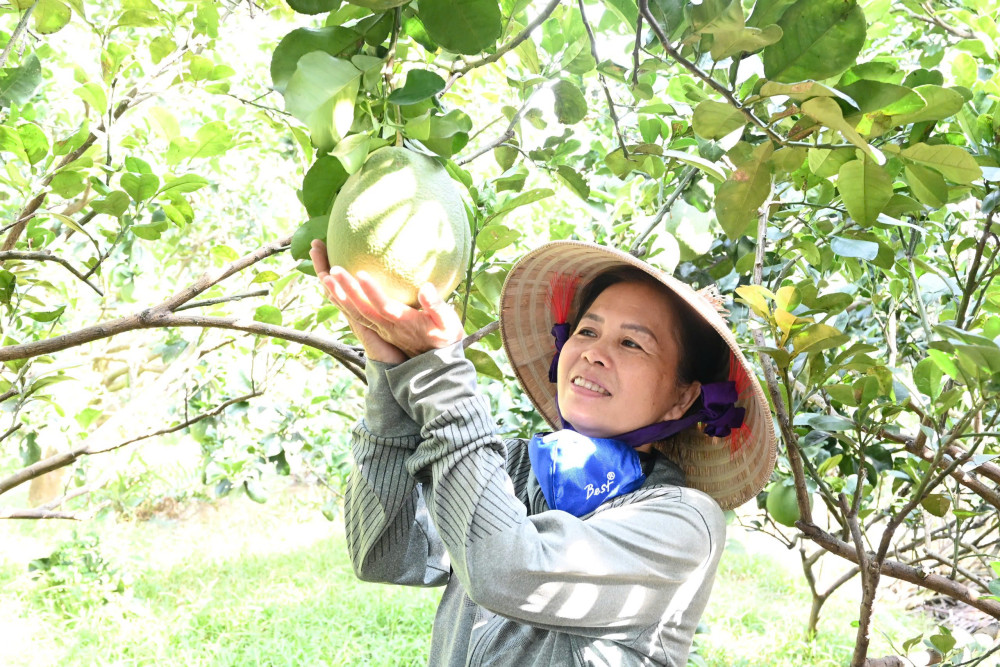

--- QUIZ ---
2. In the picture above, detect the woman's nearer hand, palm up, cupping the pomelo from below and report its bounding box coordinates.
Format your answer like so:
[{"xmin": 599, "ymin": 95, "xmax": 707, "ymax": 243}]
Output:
[{"xmin": 316, "ymin": 252, "xmax": 465, "ymax": 358}]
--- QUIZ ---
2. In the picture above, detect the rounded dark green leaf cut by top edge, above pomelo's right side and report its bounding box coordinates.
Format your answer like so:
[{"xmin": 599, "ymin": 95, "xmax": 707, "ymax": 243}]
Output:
[{"xmin": 417, "ymin": 0, "xmax": 503, "ymax": 55}]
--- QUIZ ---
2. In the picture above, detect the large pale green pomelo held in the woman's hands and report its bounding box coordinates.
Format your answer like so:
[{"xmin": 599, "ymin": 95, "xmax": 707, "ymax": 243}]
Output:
[{"xmin": 326, "ymin": 146, "xmax": 472, "ymax": 306}]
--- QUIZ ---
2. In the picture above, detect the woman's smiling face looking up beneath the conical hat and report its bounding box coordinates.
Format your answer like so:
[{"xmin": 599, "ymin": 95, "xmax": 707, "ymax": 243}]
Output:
[{"xmin": 556, "ymin": 283, "xmax": 701, "ymax": 438}]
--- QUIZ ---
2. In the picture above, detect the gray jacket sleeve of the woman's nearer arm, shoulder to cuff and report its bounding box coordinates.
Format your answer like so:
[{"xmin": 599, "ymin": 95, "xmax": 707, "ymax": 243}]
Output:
[{"xmin": 387, "ymin": 346, "xmax": 725, "ymax": 641}]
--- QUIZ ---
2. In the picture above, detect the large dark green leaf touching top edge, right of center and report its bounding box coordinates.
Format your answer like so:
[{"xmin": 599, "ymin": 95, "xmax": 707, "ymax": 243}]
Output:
[{"xmin": 762, "ymin": 0, "xmax": 868, "ymax": 83}]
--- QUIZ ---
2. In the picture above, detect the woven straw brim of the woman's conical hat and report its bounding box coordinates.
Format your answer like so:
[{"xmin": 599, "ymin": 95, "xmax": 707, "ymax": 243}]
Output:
[{"xmin": 500, "ymin": 241, "xmax": 777, "ymax": 510}]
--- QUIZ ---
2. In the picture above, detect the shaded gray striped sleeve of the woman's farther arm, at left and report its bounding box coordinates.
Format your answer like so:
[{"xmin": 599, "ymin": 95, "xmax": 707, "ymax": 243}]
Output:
[{"xmin": 344, "ymin": 360, "xmax": 450, "ymax": 586}]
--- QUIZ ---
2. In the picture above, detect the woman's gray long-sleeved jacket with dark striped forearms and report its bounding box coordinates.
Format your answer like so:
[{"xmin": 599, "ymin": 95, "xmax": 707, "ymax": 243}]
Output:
[{"xmin": 344, "ymin": 344, "xmax": 726, "ymax": 667}]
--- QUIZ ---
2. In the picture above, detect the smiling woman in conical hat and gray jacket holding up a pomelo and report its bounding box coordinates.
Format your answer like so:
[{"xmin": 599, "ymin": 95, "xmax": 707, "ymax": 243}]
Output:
[{"xmin": 311, "ymin": 242, "xmax": 775, "ymax": 667}]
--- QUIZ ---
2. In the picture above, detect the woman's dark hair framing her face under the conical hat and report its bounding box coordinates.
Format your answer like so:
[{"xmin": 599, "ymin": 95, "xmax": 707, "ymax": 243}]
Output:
[{"xmin": 571, "ymin": 267, "xmax": 729, "ymax": 388}]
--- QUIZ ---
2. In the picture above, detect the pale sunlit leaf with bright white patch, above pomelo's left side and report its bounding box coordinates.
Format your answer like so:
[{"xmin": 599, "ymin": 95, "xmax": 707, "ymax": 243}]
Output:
[{"xmin": 284, "ymin": 51, "xmax": 361, "ymax": 151}]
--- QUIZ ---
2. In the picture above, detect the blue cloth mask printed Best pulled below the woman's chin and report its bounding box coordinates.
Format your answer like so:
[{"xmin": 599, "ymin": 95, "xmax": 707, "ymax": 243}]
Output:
[{"xmin": 528, "ymin": 429, "xmax": 646, "ymax": 517}]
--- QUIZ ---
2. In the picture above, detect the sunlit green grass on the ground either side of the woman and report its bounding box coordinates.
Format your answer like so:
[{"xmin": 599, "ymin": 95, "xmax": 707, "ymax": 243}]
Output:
[{"xmin": 0, "ymin": 489, "xmax": 924, "ymax": 667}]
